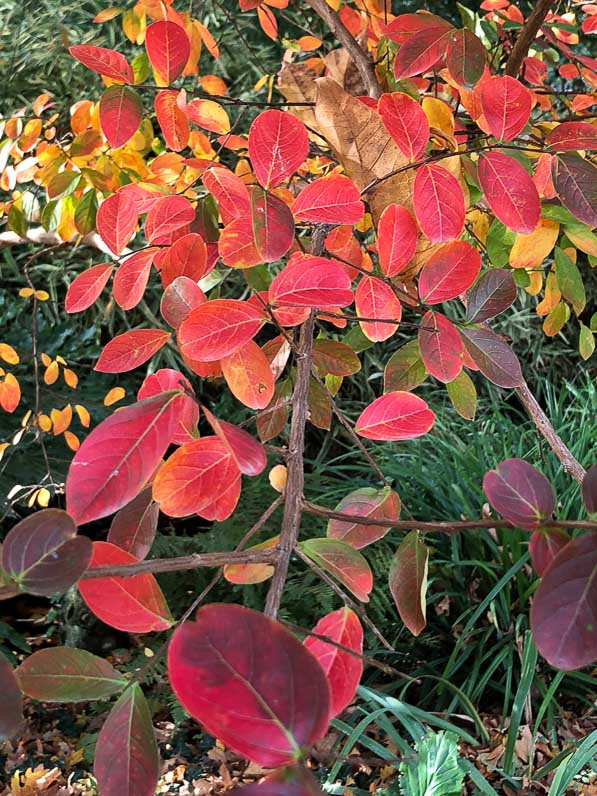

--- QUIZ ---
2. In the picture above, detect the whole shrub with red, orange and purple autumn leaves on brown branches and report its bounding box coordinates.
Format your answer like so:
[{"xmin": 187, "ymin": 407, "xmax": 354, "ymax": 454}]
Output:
[{"xmin": 0, "ymin": 0, "xmax": 597, "ymax": 796}]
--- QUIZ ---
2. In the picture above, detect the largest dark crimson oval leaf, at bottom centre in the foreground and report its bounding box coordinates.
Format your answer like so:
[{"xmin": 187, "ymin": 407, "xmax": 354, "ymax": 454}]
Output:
[{"xmin": 168, "ymin": 603, "xmax": 330, "ymax": 768}]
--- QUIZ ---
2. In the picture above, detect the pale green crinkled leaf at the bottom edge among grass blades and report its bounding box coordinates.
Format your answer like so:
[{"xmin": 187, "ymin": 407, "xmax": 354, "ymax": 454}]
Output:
[{"xmin": 400, "ymin": 732, "xmax": 465, "ymax": 796}]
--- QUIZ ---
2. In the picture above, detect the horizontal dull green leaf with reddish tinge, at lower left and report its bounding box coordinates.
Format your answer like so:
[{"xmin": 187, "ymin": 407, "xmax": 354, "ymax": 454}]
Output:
[{"xmin": 15, "ymin": 647, "xmax": 127, "ymax": 702}]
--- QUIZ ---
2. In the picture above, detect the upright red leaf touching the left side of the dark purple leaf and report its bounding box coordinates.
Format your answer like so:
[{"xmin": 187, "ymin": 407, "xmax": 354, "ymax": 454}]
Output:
[{"xmin": 419, "ymin": 311, "xmax": 463, "ymax": 384}]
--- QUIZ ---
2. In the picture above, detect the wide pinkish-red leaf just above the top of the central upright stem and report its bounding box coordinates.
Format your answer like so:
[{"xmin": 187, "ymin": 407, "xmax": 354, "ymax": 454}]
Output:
[{"xmin": 292, "ymin": 174, "xmax": 365, "ymax": 224}]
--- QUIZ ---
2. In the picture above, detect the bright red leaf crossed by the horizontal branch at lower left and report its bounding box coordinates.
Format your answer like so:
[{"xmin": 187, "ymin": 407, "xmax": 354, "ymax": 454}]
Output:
[{"xmin": 77, "ymin": 542, "xmax": 172, "ymax": 633}]
